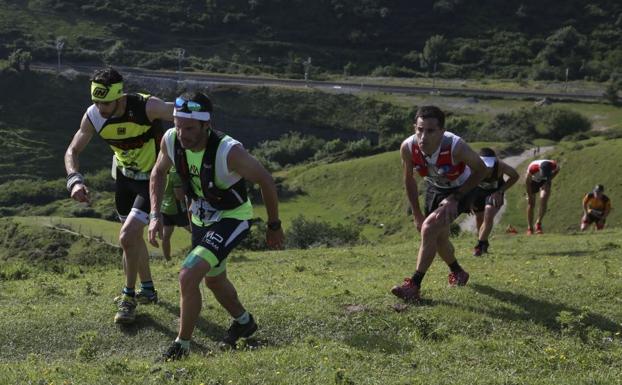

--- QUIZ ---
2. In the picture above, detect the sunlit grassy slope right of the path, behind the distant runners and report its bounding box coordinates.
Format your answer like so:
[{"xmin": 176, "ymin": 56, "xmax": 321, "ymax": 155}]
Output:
[{"xmin": 503, "ymin": 138, "xmax": 622, "ymax": 232}]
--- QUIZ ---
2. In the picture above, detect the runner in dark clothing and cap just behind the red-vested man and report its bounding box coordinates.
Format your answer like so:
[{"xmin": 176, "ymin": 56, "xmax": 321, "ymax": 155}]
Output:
[{"xmin": 473, "ymin": 147, "xmax": 519, "ymax": 256}]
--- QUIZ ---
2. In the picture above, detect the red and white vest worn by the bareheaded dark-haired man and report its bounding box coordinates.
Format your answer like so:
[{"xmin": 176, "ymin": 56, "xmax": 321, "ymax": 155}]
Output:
[{"xmin": 406, "ymin": 131, "xmax": 471, "ymax": 188}]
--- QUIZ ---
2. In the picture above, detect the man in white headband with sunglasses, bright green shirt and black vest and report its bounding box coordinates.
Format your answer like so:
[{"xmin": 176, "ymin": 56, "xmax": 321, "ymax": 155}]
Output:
[{"xmin": 149, "ymin": 93, "xmax": 283, "ymax": 360}]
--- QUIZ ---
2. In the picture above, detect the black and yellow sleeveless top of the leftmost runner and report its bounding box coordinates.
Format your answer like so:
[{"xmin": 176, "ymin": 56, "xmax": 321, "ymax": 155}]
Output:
[{"xmin": 86, "ymin": 94, "xmax": 163, "ymax": 180}]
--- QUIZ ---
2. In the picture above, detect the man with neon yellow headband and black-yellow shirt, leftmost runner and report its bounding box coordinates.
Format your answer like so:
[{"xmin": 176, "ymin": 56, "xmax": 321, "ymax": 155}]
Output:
[{"xmin": 65, "ymin": 68, "xmax": 173, "ymax": 323}]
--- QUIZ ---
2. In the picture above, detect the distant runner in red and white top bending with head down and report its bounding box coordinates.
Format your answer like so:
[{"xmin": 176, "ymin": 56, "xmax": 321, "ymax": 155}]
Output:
[{"xmin": 525, "ymin": 159, "xmax": 559, "ymax": 235}]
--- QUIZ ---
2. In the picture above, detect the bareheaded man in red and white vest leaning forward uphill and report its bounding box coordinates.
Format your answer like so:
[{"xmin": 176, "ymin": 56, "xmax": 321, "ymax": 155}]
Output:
[{"xmin": 391, "ymin": 106, "xmax": 486, "ymax": 301}]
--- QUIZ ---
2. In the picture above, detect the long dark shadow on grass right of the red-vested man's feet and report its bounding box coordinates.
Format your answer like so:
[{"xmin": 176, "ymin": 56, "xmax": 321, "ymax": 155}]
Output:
[{"xmin": 469, "ymin": 283, "xmax": 618, "ymax": 332}]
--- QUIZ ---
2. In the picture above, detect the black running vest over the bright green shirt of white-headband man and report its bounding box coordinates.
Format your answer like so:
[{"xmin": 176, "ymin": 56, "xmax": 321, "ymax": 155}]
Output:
[{"xmin": 173, "ymin": 130, "xmax": 248, "ymax": 210}]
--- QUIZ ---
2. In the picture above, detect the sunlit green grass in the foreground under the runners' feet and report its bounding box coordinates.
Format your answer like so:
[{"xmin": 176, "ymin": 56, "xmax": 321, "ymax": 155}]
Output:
[{"xmin": 0, "ymin": 229, "xmax": 622, "ymax": 385}]
